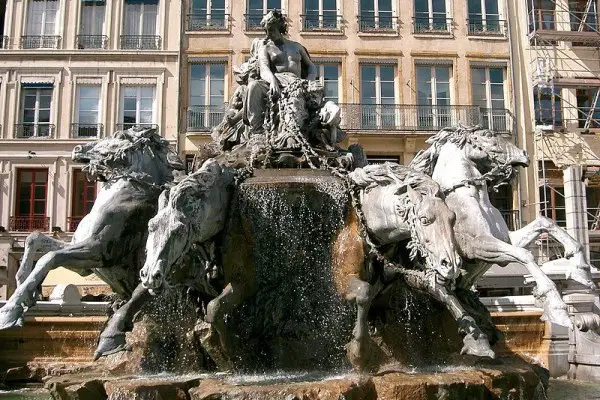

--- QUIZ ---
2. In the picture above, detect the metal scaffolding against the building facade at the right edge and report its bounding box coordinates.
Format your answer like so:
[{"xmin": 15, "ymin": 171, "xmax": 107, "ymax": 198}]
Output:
[{"xmin": 527, "ymin": 0, "xmax": 600, "ymax": 262}]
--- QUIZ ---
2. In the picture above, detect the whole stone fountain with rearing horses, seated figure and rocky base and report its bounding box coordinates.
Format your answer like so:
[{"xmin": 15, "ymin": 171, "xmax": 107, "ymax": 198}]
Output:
[{"xmin": 0, "ymin": 11, "xmax": 593, "ymax": 400}]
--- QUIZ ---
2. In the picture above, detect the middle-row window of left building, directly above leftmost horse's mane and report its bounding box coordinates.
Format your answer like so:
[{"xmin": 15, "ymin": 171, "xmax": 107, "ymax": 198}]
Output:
[{"xmin": 121, "ymin": 86, "xmax": 154, "ymax": 129}]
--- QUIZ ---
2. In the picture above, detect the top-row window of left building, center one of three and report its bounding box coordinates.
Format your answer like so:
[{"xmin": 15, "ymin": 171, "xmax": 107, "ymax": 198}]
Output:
[{"xmin": 77, "ymin": 0, "xmax": 108, "ymax": 49}]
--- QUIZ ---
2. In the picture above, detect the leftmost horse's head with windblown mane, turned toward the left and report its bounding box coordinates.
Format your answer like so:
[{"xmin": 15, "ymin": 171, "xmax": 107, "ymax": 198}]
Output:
[{"xmin": 71, "ymin": 128, "xmax": 184, "ymax": 184}]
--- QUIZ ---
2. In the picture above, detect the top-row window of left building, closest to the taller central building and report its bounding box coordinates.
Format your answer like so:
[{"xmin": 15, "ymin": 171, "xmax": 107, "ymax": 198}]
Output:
[{"xmin": 121, "ymin": 0, "xmax": 161, "ymax": 50}]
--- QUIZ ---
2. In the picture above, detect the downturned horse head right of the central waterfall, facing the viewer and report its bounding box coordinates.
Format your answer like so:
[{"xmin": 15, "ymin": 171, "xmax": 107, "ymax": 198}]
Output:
[{"xmin": 407, "ymin": 185, "xmax": 462, "ymax": 281}]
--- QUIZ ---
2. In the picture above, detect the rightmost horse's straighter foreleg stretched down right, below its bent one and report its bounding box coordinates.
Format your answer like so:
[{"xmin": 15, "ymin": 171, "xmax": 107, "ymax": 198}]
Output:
[{"xmin": 469, "ymin": 235, "xmax": 573, "ymax": 328}]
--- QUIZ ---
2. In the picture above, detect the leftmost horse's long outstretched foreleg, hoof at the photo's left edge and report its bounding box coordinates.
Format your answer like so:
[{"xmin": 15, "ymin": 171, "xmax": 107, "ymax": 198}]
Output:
[{"xmin": 0, "ymin": 239, "xmax": 102, "ymax": 330}]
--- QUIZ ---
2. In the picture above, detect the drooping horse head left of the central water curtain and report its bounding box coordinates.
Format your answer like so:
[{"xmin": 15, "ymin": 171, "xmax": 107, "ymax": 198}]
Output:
[{"xmin": 140, "ymin": 159, "xmax": 233, "ymax": 294}]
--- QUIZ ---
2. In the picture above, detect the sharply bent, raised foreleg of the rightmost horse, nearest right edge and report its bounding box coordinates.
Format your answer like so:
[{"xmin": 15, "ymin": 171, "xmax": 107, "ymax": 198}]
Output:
[{"xmin": 510, "ymin": 215, "xmax": 596, "ymax": 289}]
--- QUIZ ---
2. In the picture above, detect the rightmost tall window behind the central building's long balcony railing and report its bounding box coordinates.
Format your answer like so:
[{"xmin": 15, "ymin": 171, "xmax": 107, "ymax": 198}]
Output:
[{"xmin": 471, "ymin": 67, "xmax": 509, "ymax": 132}]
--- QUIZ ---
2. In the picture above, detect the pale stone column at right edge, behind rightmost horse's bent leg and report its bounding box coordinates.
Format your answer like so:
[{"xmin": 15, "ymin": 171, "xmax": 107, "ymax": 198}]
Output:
[{"xmin": 563, "ymin": 166, "xmax": 590, "ymax": 262}]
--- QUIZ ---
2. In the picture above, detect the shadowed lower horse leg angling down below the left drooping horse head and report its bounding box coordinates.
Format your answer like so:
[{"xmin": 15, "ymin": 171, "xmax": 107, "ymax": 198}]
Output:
[{"xmin": 94, "ymin": 283, "xmax": 152, "ymax": 361}]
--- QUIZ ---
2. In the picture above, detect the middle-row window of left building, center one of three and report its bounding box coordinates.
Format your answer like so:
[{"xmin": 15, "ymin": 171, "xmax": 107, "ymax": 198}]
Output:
[{"xmin": 72, "ymin": 85, "xmax": 102, "ymax": 137}]
